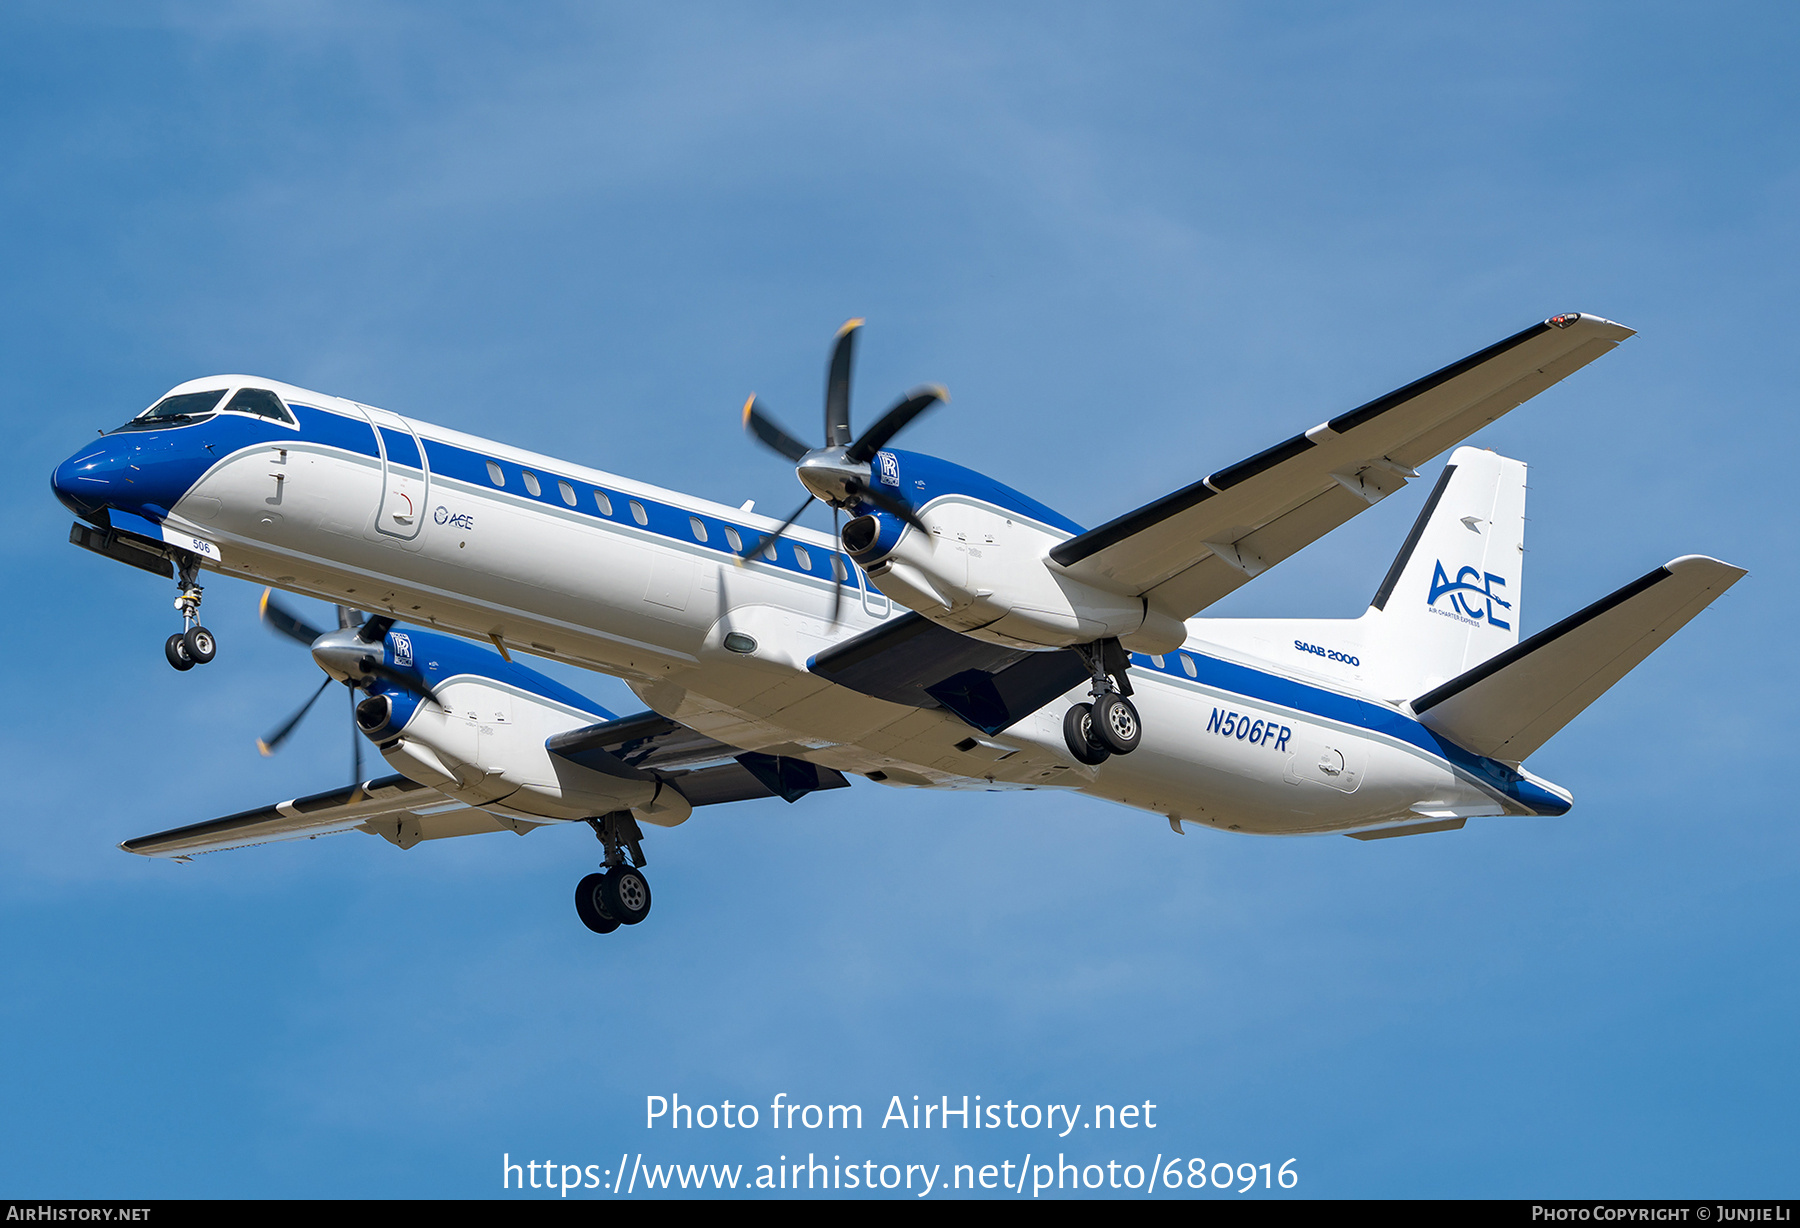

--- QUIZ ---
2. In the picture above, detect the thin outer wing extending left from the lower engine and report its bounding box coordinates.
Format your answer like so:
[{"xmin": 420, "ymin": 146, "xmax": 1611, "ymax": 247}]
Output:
[{"xmin": 119, "ymin": 776, "xmax": 536, "ymax": 857}]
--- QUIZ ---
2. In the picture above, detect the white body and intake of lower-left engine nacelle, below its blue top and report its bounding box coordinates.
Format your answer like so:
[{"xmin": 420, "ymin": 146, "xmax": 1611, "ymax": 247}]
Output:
[{"xmin": 356, "ymin": 675, "xmax": 693, "ymax": 826}]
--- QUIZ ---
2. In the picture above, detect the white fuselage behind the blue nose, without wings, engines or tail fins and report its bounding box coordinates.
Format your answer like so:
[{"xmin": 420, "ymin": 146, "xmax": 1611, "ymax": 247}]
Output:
[{"xmin": 169, "ymin": 385, "xmax": 1555, "ymax": 834}]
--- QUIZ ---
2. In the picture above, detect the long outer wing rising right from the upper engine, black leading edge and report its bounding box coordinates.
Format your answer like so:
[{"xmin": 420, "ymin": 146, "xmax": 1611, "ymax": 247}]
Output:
[{"xmin": 1049, "ymin": 313, "xmax": 1633, "ymax": 618}]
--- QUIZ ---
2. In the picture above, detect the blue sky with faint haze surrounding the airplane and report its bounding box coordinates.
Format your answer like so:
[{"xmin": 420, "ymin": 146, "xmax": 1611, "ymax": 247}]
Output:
[{"xmin": 0, "ymin": 4, "xmax": 1800, "ymax": 1197}]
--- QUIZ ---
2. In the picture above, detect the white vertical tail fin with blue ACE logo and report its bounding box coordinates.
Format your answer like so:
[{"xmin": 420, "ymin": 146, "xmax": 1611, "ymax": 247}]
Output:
[{"xmin": 1357, "ymin": 448, "xmax": 1525, "ymax": 699}]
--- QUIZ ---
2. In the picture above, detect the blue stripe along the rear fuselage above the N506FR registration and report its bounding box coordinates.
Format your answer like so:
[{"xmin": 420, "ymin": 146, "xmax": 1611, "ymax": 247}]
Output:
[{"xmin": 1132, "ymin": 650, "xmax": 1570, "ymax": 814}]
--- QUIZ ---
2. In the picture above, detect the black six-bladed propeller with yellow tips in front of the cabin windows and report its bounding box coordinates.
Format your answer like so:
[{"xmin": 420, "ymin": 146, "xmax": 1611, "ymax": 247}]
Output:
[{"xmin": 740, "ymin": 321, "xmax": 950, "ymax": 625}]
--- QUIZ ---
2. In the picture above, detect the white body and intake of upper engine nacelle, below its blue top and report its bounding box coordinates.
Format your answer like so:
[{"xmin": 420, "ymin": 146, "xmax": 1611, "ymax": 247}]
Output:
[{"xmin": 842, "ymin": 495, "xmax": 1188, "ymax": 654}]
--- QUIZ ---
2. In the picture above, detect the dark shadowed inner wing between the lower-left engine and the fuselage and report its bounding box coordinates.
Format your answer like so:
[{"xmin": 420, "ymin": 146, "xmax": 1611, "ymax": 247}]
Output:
[{"xmin": 544, "ymin": 711, "xmax": 850, "ymax": 807}]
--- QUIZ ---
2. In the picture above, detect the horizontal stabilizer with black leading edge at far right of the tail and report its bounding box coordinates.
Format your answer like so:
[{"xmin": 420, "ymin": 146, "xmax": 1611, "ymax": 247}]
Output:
[{"xmin": 1413, "ymin": 555, "xmax": 1746, "ymax": 763}]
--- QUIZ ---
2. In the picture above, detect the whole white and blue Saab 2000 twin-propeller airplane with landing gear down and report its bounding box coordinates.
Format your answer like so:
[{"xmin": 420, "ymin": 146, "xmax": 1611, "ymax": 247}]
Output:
[{"xmin": 52, "ymin": 312, "xmax": 1746, "ymax": 933}]
